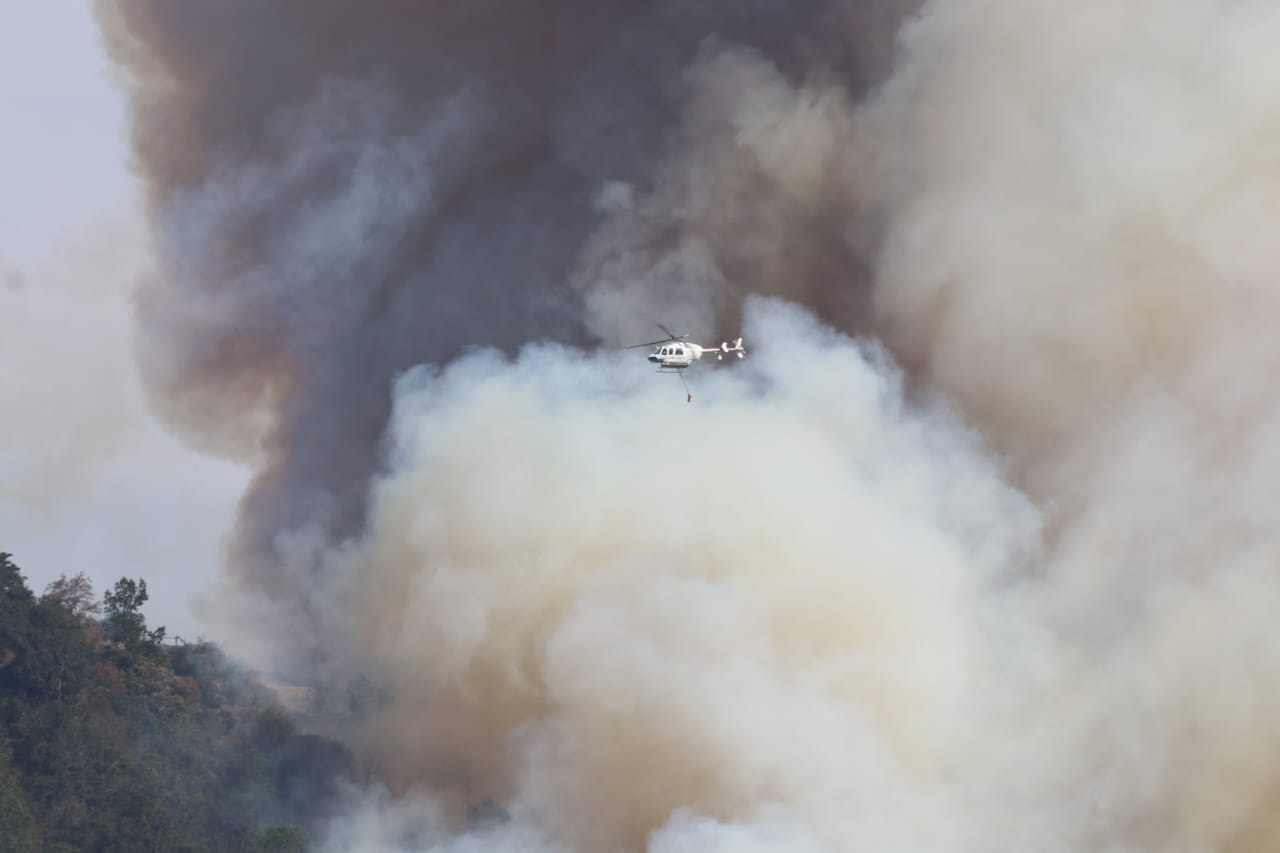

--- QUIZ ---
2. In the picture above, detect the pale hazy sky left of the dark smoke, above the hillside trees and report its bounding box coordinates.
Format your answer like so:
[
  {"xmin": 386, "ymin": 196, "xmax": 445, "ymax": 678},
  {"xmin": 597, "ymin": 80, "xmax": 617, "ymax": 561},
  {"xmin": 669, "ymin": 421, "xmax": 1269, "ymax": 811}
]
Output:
[{"xmin": 0, "ymin": 3, "xmax": 244, "ymax": 638}]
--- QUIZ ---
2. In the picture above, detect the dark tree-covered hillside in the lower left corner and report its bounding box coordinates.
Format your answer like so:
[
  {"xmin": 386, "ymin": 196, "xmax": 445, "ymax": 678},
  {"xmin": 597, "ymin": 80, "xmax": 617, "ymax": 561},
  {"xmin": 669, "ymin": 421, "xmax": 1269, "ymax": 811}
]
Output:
[{"xmin": 0, "ymin": 553, "xmax": 352, "ymax": 852}]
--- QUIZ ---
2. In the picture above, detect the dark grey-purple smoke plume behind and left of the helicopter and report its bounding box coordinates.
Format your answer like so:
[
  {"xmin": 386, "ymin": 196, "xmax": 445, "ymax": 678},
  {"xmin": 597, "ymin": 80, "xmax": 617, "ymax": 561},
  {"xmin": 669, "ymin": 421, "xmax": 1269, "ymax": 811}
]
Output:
[{"xmin": 100, "ymin": 0, "xmax": 908, "ymax": 666}]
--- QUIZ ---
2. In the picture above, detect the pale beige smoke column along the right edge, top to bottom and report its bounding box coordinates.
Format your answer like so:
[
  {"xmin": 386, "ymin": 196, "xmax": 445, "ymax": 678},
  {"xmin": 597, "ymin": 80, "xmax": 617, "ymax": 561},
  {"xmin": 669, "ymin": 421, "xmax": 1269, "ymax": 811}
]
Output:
[{"xmin": 859, "ymin": 0, "xmax": 1280, "ymax": 850}]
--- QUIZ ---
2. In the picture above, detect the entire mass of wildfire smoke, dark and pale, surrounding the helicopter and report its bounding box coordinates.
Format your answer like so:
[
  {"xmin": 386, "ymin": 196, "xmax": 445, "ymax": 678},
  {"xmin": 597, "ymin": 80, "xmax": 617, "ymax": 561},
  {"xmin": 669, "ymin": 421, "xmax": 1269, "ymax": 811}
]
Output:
[{"xmin": 102, "ymin": 0, "xmax": 1280, "ymax": 853}]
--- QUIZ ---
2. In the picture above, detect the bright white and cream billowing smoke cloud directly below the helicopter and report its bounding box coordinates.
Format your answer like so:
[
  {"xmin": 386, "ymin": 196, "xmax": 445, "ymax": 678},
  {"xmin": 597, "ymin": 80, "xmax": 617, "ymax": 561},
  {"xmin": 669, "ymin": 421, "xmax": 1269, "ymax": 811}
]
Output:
[{"xmin": 288, "ymin": 295, "xmax": 1057, "ymax": 850}]
